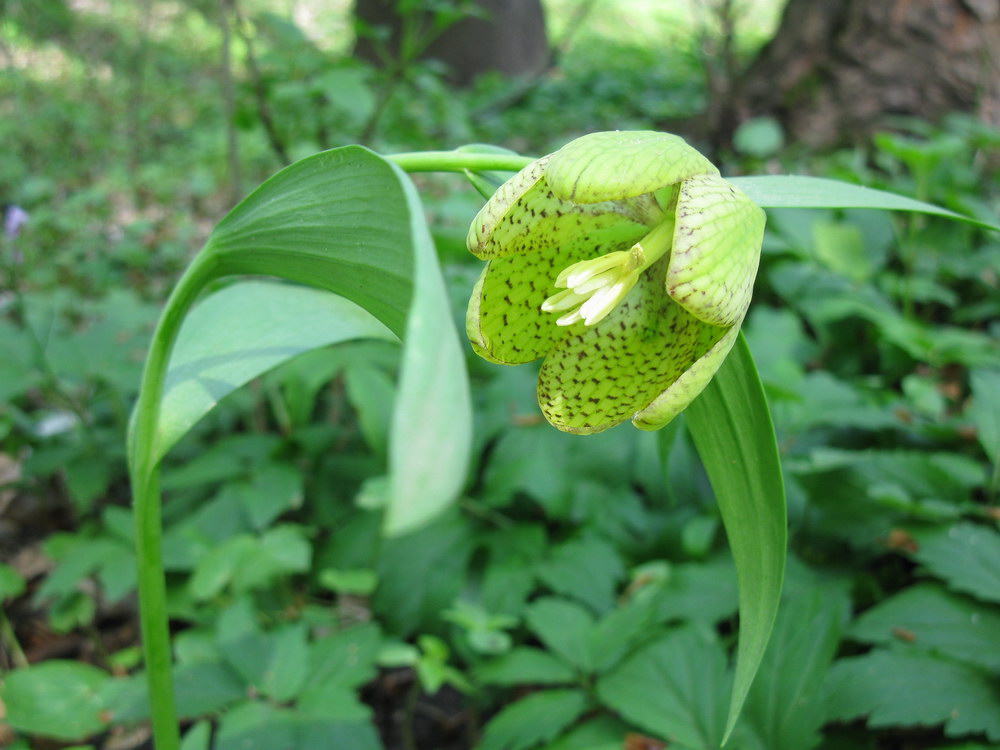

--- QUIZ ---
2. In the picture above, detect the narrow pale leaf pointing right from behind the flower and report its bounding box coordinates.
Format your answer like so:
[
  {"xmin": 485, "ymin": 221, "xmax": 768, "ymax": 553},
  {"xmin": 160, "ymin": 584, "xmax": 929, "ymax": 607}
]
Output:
[{"xmin": 729, "ymin": 175, "xmax": 1000, "ymax": 231}]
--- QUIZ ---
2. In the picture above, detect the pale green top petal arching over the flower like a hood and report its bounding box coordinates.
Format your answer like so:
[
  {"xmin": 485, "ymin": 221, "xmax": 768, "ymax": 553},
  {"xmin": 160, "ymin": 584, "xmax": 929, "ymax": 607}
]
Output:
[{"xmin": 545, "ymin": 130, "xmax": 719, "ymax": 203}]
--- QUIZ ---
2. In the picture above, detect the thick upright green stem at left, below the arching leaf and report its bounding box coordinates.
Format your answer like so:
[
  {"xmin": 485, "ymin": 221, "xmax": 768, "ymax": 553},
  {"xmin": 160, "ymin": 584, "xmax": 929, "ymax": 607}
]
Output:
[{"xmin": 128, "ymin": 248, "xmax": 218, "ymax": 750}]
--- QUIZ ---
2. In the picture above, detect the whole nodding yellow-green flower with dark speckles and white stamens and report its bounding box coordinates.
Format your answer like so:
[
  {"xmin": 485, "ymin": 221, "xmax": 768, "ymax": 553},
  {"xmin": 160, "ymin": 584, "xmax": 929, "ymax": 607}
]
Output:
[{"xmin": 466, "ymin": 131, "xmax": 765, "ymax": 434}]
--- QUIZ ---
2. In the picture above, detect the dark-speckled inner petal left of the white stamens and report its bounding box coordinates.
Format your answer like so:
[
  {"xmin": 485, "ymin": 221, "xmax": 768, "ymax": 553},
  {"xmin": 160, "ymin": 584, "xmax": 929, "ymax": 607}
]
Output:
[{"xmin": 465, "ymin": 239, "xmax": 624, "ymax": 365}]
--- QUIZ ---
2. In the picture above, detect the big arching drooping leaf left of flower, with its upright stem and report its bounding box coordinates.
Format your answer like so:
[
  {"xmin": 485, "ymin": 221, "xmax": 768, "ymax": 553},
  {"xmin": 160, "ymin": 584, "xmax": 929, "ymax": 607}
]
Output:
[{"xmin": 128, "ymin": 146, "xmax": 471, "ymax": 750}]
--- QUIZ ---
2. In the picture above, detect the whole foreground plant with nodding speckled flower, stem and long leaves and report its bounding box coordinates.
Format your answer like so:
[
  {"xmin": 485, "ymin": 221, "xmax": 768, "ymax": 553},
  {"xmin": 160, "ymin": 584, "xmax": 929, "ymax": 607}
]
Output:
[{"xmin": 128, "ymin": 132, "xmax": 982, "ymax": 750}]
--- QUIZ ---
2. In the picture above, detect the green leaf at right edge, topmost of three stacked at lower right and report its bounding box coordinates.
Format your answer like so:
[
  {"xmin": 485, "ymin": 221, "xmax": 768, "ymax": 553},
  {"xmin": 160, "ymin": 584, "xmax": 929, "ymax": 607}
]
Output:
[{"xmin": 912, "ymin": 523, "xmax": 1000, "ymax": 602}]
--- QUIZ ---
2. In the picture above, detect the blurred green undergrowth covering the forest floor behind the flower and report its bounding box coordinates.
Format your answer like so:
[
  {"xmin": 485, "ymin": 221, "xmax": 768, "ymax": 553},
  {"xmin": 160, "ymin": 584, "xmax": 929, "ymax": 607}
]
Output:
[{"xmin": 0, "ymin": 0, "xmax": 1000, "ymax": 750}]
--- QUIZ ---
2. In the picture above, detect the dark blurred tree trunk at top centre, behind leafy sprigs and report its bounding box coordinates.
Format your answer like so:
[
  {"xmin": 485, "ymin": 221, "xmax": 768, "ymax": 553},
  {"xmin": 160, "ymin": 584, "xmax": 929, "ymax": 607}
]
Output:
[{"xmin": 355, "ymin": 0, "xmax": 549, "ymax": 85}]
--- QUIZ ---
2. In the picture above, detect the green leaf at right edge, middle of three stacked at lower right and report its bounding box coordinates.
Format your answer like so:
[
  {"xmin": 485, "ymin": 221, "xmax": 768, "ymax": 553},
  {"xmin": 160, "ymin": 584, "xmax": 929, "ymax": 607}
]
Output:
[{"xmin": 848, "ymin": 583, "xmax": 1000, "ymax": 669}]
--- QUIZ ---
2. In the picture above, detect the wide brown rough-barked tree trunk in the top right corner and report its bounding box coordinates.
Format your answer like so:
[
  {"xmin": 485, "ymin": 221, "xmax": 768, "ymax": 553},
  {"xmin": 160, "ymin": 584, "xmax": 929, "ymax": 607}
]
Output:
[{"xmin": 724, "ymin": 0, "xmax": 1000, "ymax": 146}]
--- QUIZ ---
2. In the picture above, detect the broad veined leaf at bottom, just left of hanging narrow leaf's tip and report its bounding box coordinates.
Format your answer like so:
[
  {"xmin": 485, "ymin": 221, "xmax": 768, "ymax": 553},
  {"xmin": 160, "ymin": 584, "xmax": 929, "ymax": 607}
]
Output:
[{"xmin": 597, "ymin": 626, "xmax": 729, "ymax": 750}]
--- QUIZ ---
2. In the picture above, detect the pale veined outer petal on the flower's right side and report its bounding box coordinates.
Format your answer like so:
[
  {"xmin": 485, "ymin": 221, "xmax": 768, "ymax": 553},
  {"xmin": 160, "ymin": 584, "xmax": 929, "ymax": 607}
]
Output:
[{"xmin": 666, "ymin": 175, "xmax": 766, "ymax": 327}]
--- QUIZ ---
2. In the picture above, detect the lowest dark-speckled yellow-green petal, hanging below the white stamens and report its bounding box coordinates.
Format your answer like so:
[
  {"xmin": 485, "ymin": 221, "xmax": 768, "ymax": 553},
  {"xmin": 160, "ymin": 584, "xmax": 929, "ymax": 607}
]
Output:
[{"xmin": 538, "ymin": 259, "xmax": 726, "ymax": 434}]
